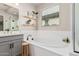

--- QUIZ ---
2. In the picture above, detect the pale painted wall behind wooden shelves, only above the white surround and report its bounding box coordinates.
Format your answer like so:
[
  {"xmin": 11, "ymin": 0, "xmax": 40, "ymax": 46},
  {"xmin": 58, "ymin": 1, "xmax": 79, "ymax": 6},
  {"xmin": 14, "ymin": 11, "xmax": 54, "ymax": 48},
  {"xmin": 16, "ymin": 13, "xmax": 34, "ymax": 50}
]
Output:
[{"xmin": 19, "ymin": 3, "xmax": 35, "ymax": 30}]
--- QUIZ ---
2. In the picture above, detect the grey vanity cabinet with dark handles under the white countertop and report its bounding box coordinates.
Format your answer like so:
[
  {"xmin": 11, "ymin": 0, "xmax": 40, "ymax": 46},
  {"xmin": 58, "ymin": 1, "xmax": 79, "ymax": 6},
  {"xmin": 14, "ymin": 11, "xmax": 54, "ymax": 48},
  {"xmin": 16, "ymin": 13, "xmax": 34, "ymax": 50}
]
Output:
[{"xmin": 0, "ymin": 36, "xmax": 23, "ymax": 56}]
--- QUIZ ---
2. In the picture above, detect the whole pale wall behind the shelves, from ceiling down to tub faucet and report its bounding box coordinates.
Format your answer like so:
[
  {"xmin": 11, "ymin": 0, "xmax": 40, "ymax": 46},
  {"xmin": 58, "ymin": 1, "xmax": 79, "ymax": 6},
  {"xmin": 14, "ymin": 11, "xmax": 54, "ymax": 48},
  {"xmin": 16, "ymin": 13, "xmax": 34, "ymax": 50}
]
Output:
[{"xmin": 19, "ymin": 3, "xmax": 36, "ymax": 40}]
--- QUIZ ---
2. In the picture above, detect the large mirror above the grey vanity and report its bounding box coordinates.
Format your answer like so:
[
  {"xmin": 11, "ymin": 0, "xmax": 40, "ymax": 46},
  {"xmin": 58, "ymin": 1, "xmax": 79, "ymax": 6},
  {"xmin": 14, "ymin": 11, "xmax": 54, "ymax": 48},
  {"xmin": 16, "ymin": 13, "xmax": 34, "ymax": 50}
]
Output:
[{"xmin": 0, "ymin": 3, "xmax": 19, "ymax": 31}]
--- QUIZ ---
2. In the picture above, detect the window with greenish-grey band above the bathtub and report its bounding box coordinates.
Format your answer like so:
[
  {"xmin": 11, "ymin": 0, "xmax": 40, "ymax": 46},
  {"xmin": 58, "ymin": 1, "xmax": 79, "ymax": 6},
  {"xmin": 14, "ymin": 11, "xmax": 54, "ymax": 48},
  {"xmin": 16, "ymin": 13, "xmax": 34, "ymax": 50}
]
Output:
[{"xmin": 42, "ymin": 5, "xmax": 60, "ymax": 26}]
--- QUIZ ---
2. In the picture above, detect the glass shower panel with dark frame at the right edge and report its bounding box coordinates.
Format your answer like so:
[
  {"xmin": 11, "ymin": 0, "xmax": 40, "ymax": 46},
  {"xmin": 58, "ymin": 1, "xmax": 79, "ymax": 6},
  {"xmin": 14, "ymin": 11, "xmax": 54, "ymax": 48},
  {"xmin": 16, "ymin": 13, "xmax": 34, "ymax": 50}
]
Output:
[{"xmin": 74, "ymin": 3, "xmax": 79, "ymax": 52}]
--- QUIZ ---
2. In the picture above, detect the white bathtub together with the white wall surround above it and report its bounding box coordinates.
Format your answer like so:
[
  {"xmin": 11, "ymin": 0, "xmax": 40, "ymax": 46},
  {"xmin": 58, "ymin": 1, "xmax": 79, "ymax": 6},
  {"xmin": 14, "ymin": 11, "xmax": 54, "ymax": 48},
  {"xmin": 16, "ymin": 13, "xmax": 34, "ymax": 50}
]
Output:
[{"xmin": 24, "ymin": 30, "xmax": 73, "ymax": 56}]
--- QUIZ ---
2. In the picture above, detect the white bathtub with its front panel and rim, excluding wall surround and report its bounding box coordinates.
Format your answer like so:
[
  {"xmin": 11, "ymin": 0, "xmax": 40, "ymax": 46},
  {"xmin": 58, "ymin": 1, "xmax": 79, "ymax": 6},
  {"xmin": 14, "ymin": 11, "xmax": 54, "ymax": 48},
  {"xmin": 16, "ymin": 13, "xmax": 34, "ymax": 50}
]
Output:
[{"xmin": 26, "ymin": 40, "xmax": 72, "ymax": 56}]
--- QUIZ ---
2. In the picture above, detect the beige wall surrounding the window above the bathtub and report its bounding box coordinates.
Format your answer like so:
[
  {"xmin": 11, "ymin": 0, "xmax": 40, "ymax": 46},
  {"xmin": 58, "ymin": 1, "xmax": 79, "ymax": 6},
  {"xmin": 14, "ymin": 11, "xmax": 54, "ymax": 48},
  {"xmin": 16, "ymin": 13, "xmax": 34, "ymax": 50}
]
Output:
[{"xmin": 36, "ymin": 3, "xmax": 72, "ymax": 31}]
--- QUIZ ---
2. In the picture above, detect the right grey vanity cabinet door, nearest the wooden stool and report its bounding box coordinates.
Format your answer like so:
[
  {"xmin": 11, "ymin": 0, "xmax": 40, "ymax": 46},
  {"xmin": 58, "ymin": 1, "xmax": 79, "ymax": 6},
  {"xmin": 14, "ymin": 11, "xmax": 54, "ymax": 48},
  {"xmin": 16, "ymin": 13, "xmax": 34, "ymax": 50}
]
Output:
[{"xmin": 12, "ymin": 39, "xmax": 22, "ymax": 56}]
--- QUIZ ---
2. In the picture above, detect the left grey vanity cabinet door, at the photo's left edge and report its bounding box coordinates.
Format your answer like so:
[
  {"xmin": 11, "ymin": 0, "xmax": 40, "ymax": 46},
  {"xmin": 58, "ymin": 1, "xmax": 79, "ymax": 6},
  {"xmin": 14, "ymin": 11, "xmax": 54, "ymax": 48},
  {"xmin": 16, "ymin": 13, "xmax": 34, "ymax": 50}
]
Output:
[{"xmin": 0, "ymin": 42, "xmax": 11, "ymax": 56}]
